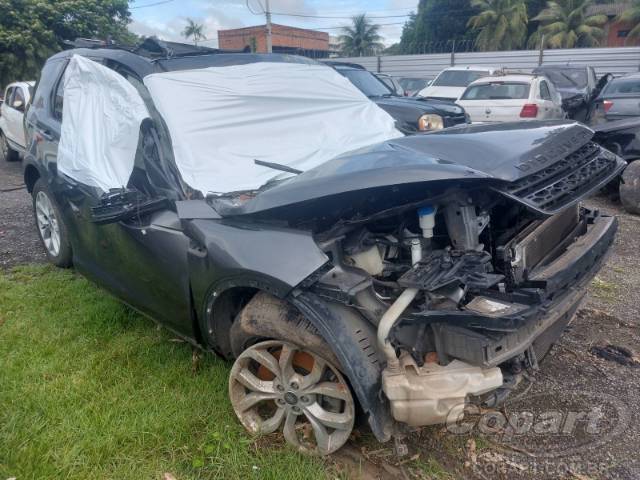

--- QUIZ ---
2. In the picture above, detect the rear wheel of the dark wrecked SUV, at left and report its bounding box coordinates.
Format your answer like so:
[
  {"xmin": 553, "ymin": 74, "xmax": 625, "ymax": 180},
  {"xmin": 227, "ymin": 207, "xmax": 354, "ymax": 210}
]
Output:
[{"xmin": 31, "ymin": 179, "xmax": 72, "ymax": 268}]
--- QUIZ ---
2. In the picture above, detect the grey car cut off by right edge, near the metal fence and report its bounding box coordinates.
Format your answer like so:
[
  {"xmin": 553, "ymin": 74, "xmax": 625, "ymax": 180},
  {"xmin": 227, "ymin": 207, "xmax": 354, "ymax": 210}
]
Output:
[{"xmin": 589, "ymin": 73, "xmax": 640, "ymax": 125}]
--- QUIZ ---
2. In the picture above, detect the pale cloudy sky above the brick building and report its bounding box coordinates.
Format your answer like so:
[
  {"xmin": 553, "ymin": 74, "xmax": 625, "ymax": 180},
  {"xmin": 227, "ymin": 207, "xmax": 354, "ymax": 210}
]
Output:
[{"xmin": 129, "ymin": 0, "xmax": 418, "ymax": 47}]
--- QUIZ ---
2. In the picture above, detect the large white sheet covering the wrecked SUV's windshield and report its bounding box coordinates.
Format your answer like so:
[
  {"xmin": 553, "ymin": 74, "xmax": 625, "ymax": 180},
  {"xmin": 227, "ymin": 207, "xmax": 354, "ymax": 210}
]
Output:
[{"xmin": 144, "ymin": 62, "xmax": 402, "ymax": 193}]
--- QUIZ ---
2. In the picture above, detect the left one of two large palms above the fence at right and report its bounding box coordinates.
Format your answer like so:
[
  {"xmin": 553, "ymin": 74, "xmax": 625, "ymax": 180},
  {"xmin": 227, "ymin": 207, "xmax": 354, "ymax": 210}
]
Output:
[{"xmin": 467, "ymin": 0, "xmax": 527, "ymax": 51}]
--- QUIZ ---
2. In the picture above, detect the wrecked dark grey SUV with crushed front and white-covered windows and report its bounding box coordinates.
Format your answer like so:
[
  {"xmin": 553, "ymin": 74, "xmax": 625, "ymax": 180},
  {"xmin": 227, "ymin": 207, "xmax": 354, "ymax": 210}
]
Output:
[{"xmin": 24, "ymin": 40, "xmax": 624, "ymax": 454}]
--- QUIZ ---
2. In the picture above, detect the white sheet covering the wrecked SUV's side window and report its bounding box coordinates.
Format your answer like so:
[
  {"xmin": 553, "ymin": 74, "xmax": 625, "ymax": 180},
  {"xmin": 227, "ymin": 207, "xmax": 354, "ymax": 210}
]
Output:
[{"xmin": 58, "ymin": 55, "xmax": 149, "ymax": 192}]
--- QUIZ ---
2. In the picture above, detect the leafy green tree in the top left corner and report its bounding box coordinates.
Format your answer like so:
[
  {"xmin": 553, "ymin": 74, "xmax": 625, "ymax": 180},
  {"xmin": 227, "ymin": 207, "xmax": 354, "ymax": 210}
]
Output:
[{"xmin": 0, "ymin": 0, "xmax": 135, "ymax": 86}]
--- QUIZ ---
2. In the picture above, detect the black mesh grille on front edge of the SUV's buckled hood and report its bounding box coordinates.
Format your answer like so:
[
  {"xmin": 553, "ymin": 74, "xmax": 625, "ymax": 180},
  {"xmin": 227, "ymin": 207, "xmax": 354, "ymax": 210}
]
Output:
[{"xmin": 501, "ymin": 142, "xmax": 624, "ymax": 214}]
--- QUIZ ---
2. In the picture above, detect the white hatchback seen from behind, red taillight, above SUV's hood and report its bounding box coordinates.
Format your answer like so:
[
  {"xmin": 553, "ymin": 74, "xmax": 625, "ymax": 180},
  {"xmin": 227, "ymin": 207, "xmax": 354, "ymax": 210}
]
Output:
[{"xmin": 456, "ymin": 75, "xmax": 566, "ymax": 123}]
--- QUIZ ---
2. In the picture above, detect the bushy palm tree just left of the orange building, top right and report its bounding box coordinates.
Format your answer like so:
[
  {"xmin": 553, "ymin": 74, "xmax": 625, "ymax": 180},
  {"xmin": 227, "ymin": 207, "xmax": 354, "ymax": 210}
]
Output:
[{"xmin": 529, "ymin": 0, "xmax": 607, "ymax": 48}]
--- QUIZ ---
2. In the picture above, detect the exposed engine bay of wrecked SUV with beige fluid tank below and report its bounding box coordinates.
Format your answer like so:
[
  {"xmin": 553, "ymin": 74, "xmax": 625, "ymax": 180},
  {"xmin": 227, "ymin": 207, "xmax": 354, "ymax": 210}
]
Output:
[{"xmin": 312, "ymin": 186, "xmax": 615, "ymax": 426}]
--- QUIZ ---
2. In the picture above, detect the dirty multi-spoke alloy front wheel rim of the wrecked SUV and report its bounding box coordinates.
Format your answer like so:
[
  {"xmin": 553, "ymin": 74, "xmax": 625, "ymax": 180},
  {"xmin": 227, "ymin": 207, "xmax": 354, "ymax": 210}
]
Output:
[{"xmin": 229, "ymin": 340, "xmax": 355, "ymax": 455}]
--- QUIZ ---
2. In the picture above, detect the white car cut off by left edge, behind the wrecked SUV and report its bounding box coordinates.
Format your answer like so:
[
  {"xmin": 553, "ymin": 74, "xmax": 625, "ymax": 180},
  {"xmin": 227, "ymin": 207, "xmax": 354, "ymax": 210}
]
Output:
[{"xmin": 0, "ymin": 82, "xmax": 35, "ymax": 161}]
